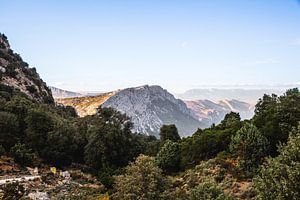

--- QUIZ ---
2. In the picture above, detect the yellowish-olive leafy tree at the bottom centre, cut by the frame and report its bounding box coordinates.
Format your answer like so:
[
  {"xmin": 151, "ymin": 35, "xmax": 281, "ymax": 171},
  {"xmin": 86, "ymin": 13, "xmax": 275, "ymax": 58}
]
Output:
[{"xmin": 112, "ymin": 155, "xmax": 168, "ymax": 200}]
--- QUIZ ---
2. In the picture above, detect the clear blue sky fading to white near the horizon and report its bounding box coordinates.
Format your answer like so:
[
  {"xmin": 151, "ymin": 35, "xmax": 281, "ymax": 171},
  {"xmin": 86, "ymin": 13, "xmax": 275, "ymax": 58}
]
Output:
[{"xmin": 0, "ymin": 0, "xmax": 300, "ymax": 93}]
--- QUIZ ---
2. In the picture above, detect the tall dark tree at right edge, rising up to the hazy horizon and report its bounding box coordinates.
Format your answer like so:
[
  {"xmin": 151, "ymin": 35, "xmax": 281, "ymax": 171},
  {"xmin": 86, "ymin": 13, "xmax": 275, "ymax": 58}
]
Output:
[{"xmin": 253, "ymin": 88, "xmax": 300, "ymax": 156}]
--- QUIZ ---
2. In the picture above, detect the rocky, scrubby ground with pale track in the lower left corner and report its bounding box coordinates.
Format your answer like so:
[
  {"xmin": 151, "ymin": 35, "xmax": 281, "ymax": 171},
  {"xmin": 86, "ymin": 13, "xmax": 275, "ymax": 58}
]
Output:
[{"xmin": 0, "ymin": 157, "xmax": 105, "ymax": 200}]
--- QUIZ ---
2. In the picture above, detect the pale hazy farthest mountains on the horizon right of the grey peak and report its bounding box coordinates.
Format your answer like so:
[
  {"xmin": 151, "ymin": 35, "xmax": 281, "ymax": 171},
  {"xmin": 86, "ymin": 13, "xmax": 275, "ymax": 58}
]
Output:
[{"xmin": 176, "ymin": 87, "xmax": 287, "ymax": 103}]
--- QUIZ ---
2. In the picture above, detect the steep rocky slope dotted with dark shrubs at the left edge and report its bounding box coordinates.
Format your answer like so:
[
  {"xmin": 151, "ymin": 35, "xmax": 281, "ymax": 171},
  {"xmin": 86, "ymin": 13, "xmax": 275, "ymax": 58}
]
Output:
[{"xmin": 0, "ymin": 33, "xmax": 54, "ymax": 103}]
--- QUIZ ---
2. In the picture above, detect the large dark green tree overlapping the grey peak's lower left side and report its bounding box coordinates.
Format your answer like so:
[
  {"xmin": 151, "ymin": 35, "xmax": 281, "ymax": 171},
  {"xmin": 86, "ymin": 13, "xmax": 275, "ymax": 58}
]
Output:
[{"xmin": 84, "ymin": 108, "xmax": 136, "ymax": 170}]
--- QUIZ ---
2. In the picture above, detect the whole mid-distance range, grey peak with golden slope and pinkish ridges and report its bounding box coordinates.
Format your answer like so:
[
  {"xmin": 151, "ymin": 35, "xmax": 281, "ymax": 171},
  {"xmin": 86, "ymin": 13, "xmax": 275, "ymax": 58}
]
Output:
[{"xmin": 52, "ymin": 85, "xmax": 253, "ymax": 136}]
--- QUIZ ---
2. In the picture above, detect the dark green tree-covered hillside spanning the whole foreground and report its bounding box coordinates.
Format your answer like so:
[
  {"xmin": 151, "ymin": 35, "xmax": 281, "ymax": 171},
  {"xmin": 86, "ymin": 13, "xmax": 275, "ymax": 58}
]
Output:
[{"xmin": 0, "ymin": 33, "xmax": 300, "ymax": 200}]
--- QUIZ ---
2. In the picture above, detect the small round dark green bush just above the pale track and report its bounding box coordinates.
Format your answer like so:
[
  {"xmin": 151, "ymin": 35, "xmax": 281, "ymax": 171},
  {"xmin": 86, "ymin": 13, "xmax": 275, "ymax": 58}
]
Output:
[{"xmin": 10, "ymin": 143, "xmax": 36, "ymax": 166}]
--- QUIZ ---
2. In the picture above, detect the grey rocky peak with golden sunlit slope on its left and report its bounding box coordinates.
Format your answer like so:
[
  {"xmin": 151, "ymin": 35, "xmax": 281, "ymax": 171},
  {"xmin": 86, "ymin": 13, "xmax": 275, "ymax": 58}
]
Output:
[{"xmin": 57, "ymin": 85, "xmax": 204, "ymax": 136}]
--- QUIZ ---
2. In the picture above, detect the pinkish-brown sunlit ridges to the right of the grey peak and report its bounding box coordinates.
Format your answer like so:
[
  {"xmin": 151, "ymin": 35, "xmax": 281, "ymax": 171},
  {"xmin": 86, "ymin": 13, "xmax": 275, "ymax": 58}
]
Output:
[{"xmin": 185, "ymin": 100, "xmax": 254, "ymax": 124}]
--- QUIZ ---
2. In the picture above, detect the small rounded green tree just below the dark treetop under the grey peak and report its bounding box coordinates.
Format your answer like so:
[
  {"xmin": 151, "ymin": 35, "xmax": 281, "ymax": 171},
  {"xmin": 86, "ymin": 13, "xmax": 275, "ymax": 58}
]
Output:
[{"xmin": 156, "ymin": 140, "xmax": 180, "ymax": 173}]
